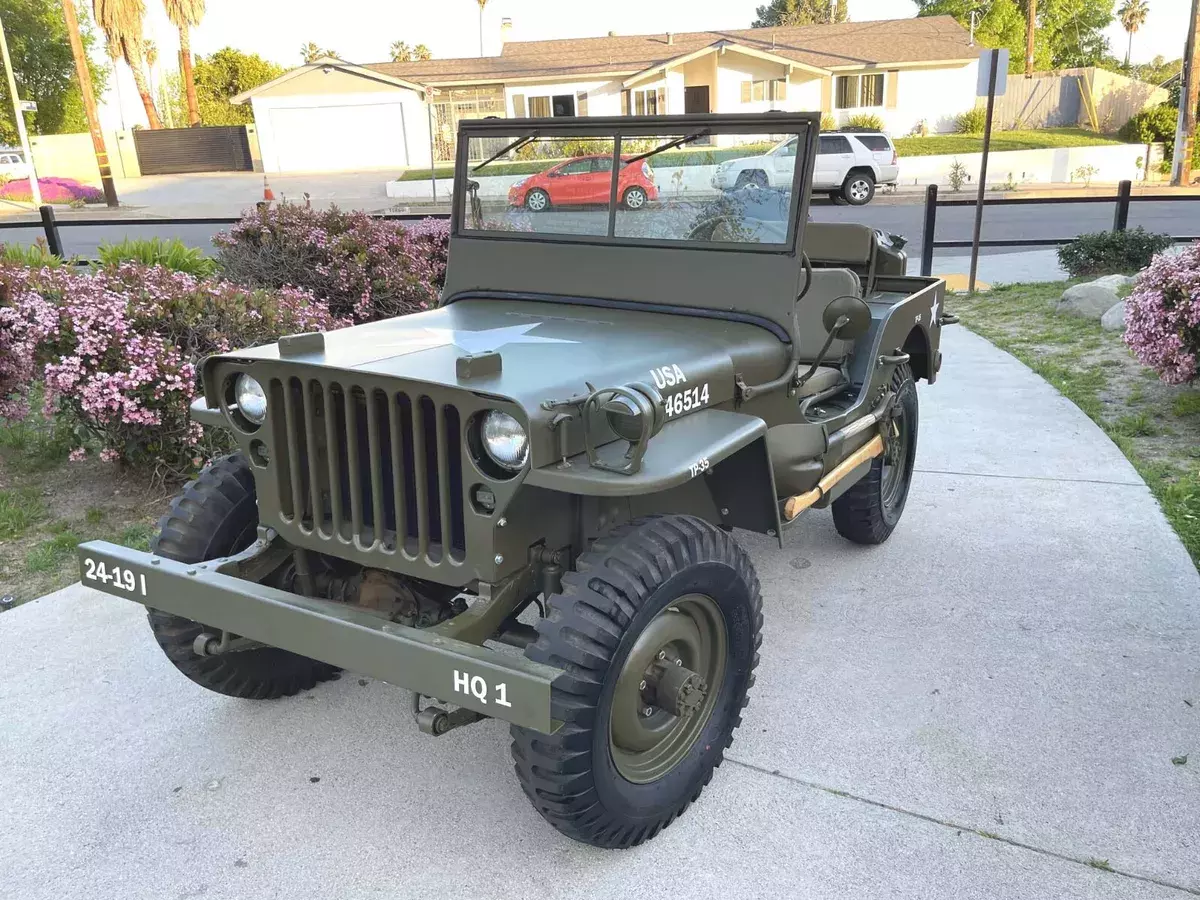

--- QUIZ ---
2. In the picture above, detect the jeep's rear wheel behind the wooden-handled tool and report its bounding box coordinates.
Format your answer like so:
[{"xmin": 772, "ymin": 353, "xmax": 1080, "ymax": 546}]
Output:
[{"xmin": 833, "ymin": 365, "xmax": 919, "ymax": 544}]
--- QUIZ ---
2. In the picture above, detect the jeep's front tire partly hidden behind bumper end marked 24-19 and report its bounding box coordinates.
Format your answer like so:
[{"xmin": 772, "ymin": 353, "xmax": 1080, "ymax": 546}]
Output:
[{"xmin": 146, "ymin": 454, "xmax": 340, "ymax": 700}]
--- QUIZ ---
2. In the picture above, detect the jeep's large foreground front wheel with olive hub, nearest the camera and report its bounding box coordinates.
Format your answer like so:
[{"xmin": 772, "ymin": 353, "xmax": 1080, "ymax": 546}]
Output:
[{"xmin": 511, "ymin": 516, "xmax": 762, "ymax": 847}]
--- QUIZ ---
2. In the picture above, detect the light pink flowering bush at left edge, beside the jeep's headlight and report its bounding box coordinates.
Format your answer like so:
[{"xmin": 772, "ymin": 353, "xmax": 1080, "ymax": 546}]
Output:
[{"xmin": 0, "ymin": 263, "xmax": 346, "ymax": 476}]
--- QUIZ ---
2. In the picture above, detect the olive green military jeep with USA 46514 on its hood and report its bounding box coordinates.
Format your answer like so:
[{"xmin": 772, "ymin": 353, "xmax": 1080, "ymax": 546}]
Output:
[{"xmin": 79, "ymin": 113, "xmax": 953, "ymax": 847}]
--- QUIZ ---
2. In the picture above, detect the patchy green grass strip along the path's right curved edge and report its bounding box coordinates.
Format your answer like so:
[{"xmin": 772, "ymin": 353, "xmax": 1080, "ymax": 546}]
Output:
[{"xmin": 948, "ymin": 282, "xmax": 1200, "ymax": 568}]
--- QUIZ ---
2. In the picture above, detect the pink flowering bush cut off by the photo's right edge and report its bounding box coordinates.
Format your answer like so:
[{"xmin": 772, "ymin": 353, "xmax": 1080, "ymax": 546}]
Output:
[{"xmin": 1124, "ymin": 244, "xmax": 1200, "ymax": 384}]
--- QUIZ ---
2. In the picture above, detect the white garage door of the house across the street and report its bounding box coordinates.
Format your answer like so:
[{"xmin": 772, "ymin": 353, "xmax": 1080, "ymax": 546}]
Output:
[{"xmin": 271, "ymin": 103, "xmax": 408, "ymax": 172}]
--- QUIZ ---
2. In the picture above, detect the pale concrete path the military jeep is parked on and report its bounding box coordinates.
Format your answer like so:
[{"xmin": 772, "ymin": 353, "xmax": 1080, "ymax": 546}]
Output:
[{"xmin": 0, "ymin": 328, "xmax": 1200, "ymax": 900}]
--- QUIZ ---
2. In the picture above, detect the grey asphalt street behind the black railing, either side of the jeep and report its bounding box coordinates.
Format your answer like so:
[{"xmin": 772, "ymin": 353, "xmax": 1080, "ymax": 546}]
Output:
[{"xmin": 0, "ymin": 194, "xmax": 1200, "ymax": 270}]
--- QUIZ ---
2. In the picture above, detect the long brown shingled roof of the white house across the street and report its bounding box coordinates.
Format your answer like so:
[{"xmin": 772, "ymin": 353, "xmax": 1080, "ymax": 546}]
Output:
[{"xmin": 366, "ymin": 16, "xmax": 980, "ymax": 84}]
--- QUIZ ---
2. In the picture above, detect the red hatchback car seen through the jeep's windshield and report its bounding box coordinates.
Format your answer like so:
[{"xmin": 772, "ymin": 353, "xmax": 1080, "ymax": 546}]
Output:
[{"xmin": 509, "ymin": 156, "xmax": 659, "ymax": 212}]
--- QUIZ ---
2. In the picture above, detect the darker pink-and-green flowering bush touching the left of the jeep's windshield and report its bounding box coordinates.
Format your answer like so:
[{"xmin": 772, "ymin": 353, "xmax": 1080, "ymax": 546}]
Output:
[{"xmin": 212, "ymin": 203, "xmax": 449, "ymax": 323}]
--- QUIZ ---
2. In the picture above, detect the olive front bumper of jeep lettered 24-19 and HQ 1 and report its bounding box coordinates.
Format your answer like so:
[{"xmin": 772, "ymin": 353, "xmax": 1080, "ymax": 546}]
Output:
[{"xmin": 78, "ymin": 541, "xmax": 560, "ymax": 733}]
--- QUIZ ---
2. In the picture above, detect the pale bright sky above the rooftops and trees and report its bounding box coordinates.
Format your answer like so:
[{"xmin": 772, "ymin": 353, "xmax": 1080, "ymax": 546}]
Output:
[{"xmin": 100, "ymin": 0, "xmax": 1189, "ymax": 127}]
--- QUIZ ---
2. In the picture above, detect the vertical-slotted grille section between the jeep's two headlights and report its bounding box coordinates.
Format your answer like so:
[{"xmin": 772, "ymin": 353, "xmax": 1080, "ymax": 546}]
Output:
[{"xmin": 270, "ymin": 377, "xmax": 467, "ymax": 565}]
